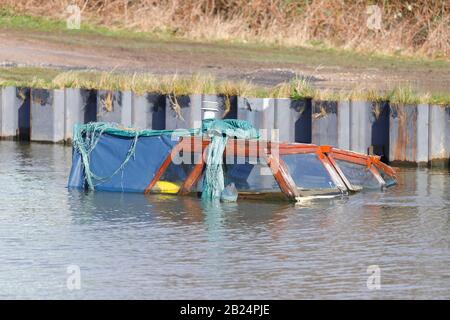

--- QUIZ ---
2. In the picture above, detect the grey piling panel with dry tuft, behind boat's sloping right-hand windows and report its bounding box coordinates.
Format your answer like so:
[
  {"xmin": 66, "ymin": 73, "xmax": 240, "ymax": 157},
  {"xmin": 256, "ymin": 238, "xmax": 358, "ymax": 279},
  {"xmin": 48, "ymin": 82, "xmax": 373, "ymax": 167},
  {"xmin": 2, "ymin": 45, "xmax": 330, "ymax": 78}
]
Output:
[{"xmin": 311, "ymin": 100, "xmax": 338, "ymax": 147}]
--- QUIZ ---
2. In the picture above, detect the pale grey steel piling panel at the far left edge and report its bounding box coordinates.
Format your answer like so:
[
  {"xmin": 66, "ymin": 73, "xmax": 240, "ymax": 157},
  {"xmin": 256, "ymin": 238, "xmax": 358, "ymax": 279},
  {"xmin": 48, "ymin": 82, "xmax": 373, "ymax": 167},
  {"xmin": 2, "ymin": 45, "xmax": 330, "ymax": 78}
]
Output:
[{"xmin": 0, "ymin": 87, "xmax": 19, "ymax": 139}]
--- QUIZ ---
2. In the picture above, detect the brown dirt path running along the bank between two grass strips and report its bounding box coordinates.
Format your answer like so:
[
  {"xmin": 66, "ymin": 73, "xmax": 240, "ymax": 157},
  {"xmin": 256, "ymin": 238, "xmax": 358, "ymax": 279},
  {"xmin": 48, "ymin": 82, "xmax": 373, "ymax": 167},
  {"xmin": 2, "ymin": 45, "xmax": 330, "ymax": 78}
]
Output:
[{"xmin": 0, "ymin": 30, "xmax": 450, "ymax": 91}]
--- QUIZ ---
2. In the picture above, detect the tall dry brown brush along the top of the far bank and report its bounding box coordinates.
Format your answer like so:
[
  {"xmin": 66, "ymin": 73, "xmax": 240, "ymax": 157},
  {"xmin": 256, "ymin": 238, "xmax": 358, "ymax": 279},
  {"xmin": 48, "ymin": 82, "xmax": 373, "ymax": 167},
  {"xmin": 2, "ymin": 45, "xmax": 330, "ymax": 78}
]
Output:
[{"xmin": 0, "ymin": 0, "xmax": 450, "ymax": 57}]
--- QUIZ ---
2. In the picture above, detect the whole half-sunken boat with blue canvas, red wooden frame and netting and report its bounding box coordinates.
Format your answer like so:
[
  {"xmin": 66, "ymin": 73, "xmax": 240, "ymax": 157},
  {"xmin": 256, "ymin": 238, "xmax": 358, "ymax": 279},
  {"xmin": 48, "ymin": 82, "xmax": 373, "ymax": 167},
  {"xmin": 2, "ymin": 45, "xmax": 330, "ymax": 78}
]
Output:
[{"xmin": 68, "ymin": 119, "xmax": 396, "ymax": 201}]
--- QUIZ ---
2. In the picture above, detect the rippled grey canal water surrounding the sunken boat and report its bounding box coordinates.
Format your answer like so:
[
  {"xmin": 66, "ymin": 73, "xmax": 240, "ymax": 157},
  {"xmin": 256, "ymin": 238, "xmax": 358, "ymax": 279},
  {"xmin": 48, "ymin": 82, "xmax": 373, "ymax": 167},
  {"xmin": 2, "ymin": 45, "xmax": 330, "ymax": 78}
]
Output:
[{"xmin": 0, "ymin": 141, "xmax": 450, "ymax": 299}]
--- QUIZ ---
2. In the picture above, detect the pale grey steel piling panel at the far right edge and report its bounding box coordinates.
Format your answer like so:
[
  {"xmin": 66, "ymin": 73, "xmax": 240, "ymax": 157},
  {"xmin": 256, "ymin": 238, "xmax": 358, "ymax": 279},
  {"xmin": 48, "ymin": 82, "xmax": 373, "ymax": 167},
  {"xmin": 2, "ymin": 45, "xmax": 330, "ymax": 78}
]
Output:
[{"xmin": 428, "ymin": 105, "xmax": 450, "ymax": 167}]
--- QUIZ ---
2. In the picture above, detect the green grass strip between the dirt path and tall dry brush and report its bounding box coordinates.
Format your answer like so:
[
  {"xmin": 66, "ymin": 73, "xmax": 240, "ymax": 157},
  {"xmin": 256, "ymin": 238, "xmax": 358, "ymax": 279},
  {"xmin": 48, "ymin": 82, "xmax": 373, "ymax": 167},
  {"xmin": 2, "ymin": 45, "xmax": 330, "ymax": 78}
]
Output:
[{"xmin": 0, "ymin": 5, "xmax": 450, "ymax": 72}]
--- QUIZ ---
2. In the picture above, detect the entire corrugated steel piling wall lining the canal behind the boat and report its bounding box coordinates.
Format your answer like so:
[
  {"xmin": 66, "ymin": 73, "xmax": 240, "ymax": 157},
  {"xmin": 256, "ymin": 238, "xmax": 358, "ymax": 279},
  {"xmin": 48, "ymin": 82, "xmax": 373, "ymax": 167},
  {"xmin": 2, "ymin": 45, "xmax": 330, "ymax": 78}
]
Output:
[{"xmin": 0, "ymin": 87, "xmax": 450, "ymax": 166}]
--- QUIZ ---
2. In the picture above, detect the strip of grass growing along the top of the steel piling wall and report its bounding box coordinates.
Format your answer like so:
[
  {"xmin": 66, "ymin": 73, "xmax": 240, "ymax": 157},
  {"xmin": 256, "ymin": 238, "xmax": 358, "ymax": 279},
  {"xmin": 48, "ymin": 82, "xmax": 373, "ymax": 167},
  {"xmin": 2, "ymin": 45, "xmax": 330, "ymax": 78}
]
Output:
[{"xmin": 0, "ymin": 67, "xmax": 450, "ymax": 106}]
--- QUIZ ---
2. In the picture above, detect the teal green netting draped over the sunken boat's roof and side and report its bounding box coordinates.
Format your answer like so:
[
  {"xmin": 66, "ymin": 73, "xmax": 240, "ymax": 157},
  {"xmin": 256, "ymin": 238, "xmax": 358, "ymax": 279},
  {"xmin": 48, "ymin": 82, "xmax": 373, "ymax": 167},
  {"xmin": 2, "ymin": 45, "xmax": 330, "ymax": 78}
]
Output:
[{"xmin": 73, "ymin": 119, "xmax": 259, "ymax": 199}]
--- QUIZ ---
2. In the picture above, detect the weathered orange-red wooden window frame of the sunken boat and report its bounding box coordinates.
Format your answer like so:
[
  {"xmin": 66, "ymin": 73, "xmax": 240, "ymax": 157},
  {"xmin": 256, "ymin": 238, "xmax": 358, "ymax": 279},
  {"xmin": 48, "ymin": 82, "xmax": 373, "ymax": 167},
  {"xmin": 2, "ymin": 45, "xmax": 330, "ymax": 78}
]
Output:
[{"xmin": 144, "ymin": 136, "xmax": 396, "ymax": 200}]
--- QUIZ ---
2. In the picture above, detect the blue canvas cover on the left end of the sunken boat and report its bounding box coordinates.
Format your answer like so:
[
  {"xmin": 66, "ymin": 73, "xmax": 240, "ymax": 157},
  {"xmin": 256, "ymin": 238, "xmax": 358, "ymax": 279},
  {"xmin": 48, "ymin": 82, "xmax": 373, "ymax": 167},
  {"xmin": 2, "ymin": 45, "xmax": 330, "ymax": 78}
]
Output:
[{"xmin": 68, "ymin": 134, "xmax": 178, "ymax": 192}]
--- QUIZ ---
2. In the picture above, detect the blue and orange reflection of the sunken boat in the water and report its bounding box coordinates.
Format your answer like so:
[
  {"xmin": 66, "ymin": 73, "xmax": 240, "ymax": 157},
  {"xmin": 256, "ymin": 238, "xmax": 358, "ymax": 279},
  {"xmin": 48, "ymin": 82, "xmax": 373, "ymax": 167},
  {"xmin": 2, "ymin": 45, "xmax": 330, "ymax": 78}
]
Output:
[{"xmin": 67, "ymin": 189, "xmax": 294, "ymax": 229}]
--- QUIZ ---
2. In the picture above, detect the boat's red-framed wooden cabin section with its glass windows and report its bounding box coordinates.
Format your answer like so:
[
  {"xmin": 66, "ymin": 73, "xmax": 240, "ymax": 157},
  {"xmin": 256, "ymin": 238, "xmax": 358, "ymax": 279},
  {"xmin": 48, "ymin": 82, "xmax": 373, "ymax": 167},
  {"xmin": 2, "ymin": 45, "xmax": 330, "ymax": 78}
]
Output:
[{"xmin": 145, "ymin": 137, "xmax": 396, "ymax": 199}]
